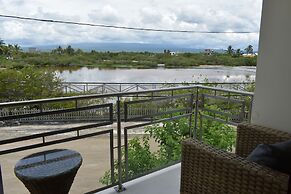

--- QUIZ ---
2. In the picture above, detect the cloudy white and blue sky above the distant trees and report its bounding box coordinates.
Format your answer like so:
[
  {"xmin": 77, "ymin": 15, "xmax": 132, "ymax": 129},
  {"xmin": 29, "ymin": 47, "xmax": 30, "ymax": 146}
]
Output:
[{"xmin": 0, "ymin": 0, "xmax": 262, "ymax": 48}]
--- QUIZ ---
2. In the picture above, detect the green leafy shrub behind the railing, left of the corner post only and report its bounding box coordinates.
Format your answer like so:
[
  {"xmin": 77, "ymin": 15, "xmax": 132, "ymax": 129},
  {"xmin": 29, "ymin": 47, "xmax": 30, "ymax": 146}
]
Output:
[{"xmin": 99, "ymin": 119, "xmax": 189, "ymax": 185}]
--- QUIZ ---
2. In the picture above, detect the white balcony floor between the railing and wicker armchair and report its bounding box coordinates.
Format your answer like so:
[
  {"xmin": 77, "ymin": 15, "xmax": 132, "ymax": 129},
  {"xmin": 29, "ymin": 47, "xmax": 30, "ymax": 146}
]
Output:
[{"xmin": 96, "ymin": 163, "xmax": 181, "ymax": 194}]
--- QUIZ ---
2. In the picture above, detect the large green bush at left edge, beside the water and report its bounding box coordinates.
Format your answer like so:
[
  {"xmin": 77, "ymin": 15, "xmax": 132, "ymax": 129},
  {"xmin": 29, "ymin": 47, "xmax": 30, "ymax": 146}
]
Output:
[{"xmin": 0, "ymin": 67, "xmax": 62, "ymax": 102}]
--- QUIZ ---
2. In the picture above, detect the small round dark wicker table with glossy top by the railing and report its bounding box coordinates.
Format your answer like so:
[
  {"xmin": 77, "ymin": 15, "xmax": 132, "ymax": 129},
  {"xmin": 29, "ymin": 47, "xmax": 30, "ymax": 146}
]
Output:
[{"xmin": 14, "ymin": 149, "xmax": 82, "ymax": 194}]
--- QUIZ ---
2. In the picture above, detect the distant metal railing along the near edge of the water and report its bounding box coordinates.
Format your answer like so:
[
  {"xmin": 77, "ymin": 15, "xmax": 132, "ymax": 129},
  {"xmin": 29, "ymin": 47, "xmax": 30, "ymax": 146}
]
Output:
[{"xmin": 62, "ymin": 81, "xmax": 254, "ymax": 94}]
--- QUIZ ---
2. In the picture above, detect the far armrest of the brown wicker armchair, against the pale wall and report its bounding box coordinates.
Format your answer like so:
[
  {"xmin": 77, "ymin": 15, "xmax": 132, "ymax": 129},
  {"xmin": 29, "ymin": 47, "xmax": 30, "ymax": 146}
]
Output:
[{"xmin": 235, "ymin": 123, "xmax": 291, "ymax": 158}]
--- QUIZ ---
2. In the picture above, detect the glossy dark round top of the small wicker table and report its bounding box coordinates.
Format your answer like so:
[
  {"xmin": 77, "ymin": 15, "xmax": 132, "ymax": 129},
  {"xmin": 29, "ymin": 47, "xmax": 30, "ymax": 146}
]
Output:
[{"xmin": 14, "ymin": 149, "xmax": 82, "ymax": 179}]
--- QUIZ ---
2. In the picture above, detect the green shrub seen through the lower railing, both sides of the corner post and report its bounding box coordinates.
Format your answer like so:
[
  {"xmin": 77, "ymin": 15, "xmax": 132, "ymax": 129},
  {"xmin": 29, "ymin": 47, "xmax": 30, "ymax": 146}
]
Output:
[{"xmin": 99, "ymin": 115, "xmax": 235, "ymax": 185}]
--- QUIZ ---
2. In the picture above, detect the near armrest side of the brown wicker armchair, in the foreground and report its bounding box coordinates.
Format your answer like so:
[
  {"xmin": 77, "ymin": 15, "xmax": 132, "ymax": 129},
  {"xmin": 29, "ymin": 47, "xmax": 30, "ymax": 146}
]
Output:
[{"xmin": 180, "ymin": 139, "xmax": 289, "ymax": 194}]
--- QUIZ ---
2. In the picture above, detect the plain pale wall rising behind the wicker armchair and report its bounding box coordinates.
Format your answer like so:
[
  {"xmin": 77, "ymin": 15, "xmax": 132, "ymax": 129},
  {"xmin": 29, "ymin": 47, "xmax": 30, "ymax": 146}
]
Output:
[{"xmin": 252, "ymin": 0, "xmax": 291, "ymax": 132}]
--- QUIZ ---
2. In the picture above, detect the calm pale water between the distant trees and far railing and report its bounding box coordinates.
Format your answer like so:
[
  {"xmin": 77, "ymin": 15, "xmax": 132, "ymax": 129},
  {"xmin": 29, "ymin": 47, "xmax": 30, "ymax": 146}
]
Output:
[{"xmin": 58, "ymin": 66, "xmax": 256, "ymax": 82}]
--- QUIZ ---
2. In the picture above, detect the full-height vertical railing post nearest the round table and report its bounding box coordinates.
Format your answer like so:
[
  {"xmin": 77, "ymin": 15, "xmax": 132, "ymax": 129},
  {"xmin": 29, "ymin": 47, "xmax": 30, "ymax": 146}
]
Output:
[{"xmin": 116, "ymin": 96, "xmax": 125, "ymax": 192}]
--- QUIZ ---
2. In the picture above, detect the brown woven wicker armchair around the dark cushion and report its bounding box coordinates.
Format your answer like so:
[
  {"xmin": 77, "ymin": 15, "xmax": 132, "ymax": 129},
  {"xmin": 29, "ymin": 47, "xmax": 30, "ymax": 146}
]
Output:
[{"xmin": 180, "ymin": 124, "xmax": 291, "ymax": 194}]
